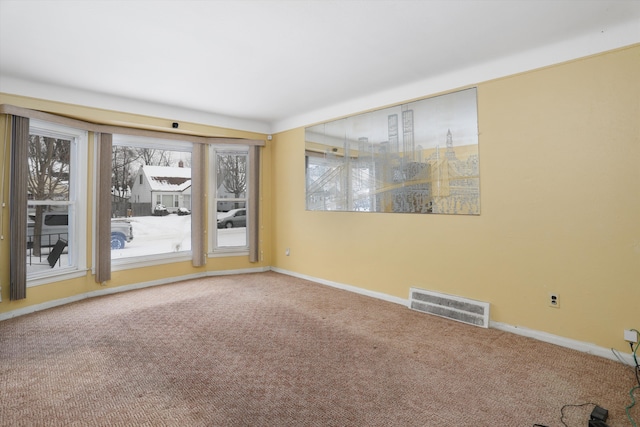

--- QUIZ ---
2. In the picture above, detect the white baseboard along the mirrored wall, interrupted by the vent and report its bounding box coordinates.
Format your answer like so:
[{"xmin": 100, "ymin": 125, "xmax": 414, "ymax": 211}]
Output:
[{"xmin": 271, "ymin": 267, "xmax": 635, "ymax": 366}]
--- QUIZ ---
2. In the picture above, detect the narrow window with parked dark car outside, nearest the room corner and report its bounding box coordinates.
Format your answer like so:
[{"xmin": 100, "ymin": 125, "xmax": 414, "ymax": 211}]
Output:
[{"xmin": 209, "ymin": 146, "xmax": 249, "ymax": 253}]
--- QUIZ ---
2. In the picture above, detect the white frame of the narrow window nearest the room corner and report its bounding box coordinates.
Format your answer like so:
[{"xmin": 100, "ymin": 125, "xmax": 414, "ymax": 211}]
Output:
[{"xmin": 207, "ymin": 144, "xmax": 252, "ymax": 258}]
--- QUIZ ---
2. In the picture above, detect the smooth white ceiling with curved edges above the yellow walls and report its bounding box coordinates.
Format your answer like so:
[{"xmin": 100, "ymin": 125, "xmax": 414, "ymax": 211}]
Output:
[{"xmin": 0, "ymin": 0, "xmax": 640, "ymax": 133}]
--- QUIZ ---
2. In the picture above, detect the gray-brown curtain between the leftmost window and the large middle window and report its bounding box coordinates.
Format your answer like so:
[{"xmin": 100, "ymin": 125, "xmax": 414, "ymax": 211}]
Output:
[{"xmin": 96, "ymin": 133, "xmax": 113, "ymax": 283}]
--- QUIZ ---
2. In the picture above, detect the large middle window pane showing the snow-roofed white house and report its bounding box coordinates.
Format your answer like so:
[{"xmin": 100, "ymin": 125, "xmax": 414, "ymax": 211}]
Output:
[{"xmin": 110, "ymin": 135, "xmax": 192, "ymax": 266}]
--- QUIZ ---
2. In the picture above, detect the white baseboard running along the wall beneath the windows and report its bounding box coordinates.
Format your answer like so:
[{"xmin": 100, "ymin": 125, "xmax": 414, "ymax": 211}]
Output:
[{"xmin": 0, "ymin": 267, "xmax": 270, "ymax": 321}]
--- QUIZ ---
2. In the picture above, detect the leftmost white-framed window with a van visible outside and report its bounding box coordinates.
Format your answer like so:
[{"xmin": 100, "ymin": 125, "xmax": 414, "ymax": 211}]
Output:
[{"xmin": 26, "ymin": 120, "xmax": 88, "ymax": 286}]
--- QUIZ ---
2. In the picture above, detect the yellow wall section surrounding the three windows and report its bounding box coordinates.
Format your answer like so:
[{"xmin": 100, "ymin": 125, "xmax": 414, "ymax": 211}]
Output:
[{"xmin": 0, "ymin": 94, "xmax": 271, "ymax": 313}]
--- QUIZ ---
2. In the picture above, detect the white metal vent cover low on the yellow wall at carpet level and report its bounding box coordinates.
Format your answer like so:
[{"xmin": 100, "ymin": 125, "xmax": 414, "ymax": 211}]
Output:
[{"xmin": 409, "ymin": 288, "xmax": 489, "ymax": 328}]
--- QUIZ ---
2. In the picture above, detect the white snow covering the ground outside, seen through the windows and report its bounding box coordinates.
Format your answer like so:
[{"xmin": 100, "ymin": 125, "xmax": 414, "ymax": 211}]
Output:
[{"xmin": 27, "ymin": 214, "xmax": 247, "ymax": 275}]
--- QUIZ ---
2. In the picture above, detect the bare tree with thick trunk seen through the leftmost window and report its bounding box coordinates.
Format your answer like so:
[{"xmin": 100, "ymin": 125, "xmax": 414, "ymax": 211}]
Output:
[{"xmin": 27, "ymin": 135, "xmax": 71, "ymax": 256}]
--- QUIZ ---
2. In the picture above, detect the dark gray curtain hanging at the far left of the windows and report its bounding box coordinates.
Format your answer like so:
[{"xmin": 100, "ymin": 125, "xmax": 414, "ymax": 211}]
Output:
[{"xmin": 9, "ymin": 116, "xmax": 29, "ymax": 300}]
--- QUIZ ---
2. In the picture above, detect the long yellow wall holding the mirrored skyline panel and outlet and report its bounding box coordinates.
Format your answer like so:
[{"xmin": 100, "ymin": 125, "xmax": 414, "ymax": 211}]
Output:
[{"xmin": 272, "ymin": 45, "xmax": 640, "ymax": 352}]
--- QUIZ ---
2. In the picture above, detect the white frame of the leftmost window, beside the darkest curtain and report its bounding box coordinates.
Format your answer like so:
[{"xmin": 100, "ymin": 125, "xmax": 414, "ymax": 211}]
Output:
[{"xmin": 26, "ymin": 119, "xmax": 91, "ymax": 288}]
